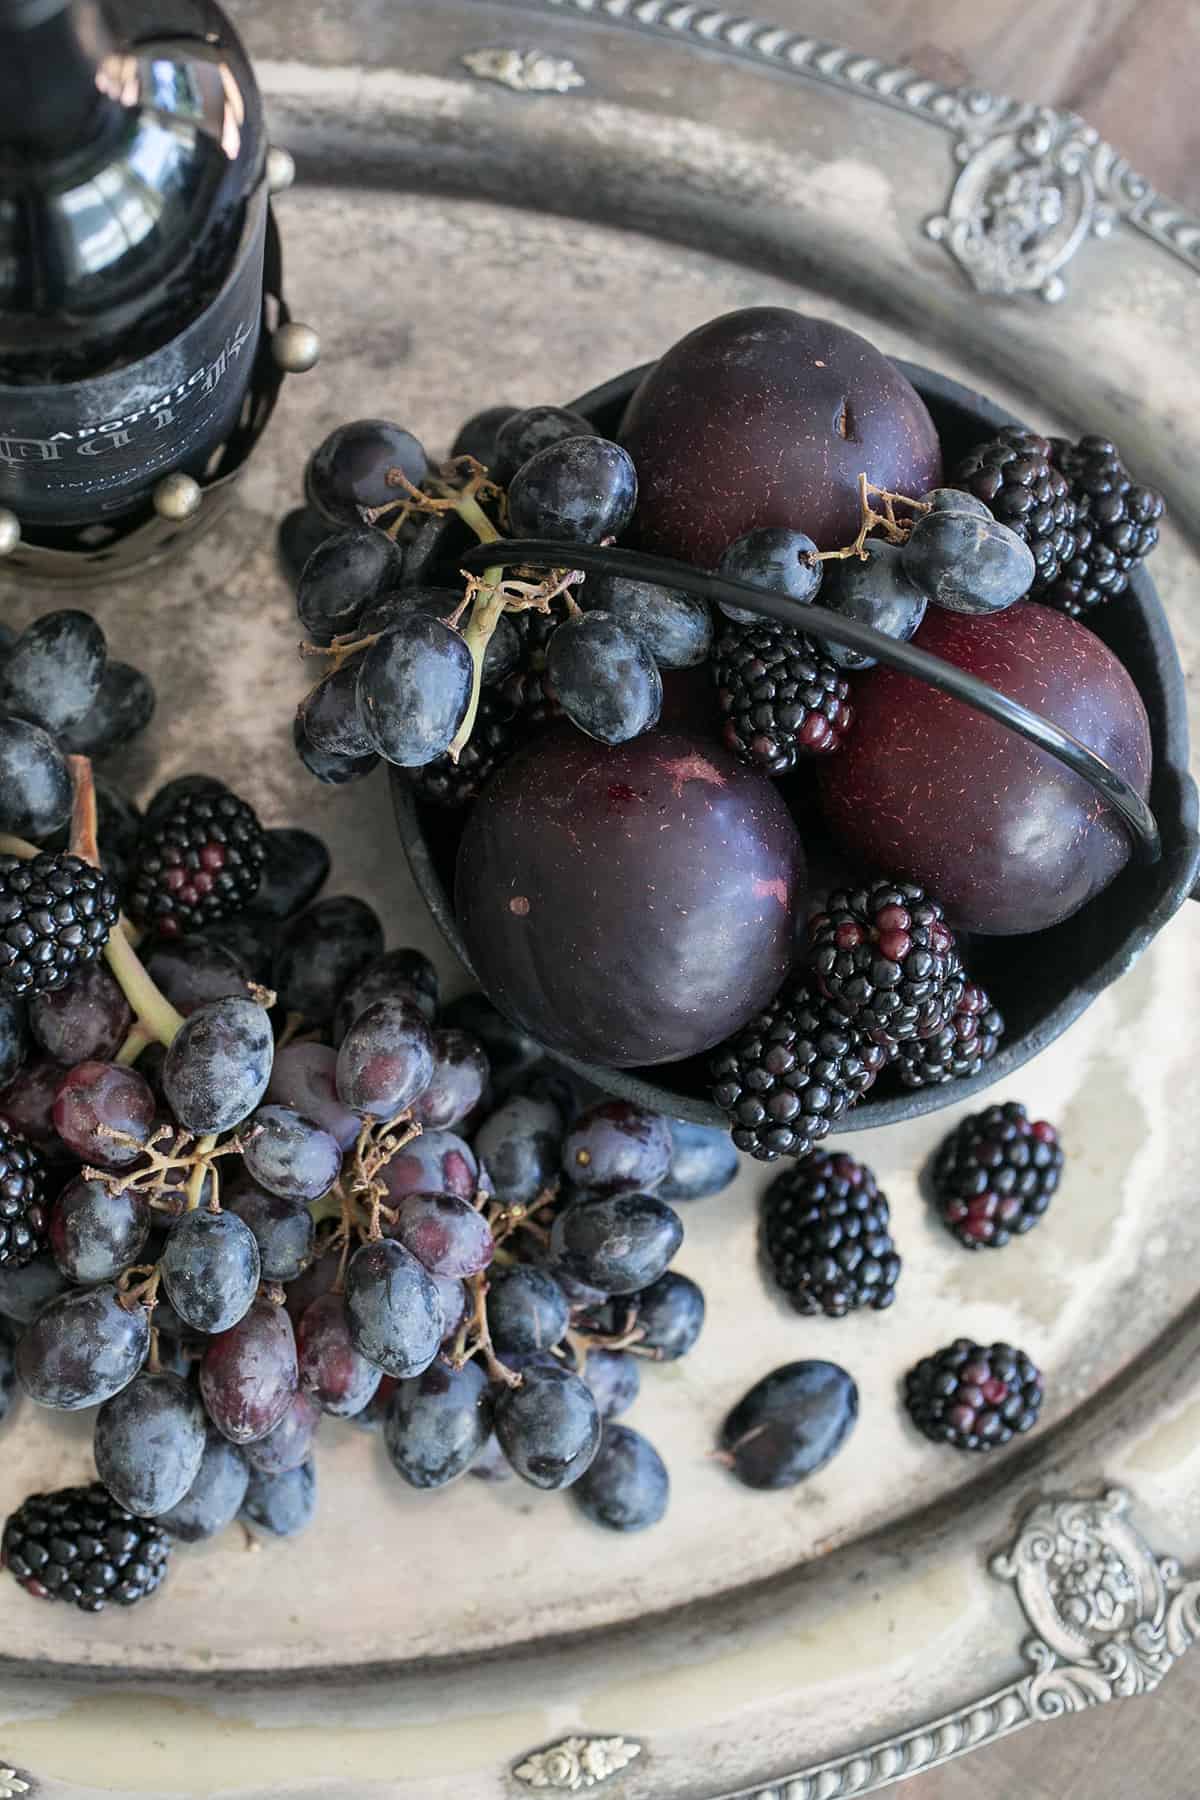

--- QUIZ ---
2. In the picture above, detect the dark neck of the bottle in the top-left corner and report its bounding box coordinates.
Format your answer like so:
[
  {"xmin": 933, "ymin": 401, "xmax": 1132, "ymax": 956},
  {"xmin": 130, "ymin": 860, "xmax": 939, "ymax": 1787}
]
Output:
[{"xmin": 0, "ymin": 0, "xmax": 117, "ymax": 158}]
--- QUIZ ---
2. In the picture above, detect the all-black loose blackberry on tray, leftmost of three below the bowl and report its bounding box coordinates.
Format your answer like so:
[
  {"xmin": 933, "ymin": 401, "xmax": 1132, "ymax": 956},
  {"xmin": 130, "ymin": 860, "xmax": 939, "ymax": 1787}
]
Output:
[{"xmin": 763, "ymin": 1150, "xmax": 900, "ymax": 1319}]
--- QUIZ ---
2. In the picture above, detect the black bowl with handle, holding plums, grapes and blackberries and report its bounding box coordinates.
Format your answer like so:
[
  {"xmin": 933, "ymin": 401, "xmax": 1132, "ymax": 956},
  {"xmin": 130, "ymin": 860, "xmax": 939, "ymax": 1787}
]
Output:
[{"xmin": 392, "ymin": 362, "xmax": 1200, "ymax": 1132}]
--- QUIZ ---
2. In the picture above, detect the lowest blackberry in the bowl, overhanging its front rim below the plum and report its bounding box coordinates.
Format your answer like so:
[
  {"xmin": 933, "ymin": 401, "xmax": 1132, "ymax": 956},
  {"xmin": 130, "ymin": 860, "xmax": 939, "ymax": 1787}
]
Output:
[{"xmin": 711, "ymin": 985, "xmax": 887, "ymax": 1163}]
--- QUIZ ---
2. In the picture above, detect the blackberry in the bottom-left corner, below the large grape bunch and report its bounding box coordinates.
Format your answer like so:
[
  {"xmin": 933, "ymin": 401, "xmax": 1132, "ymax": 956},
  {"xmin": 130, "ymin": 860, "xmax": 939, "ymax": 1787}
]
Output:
[{"xmin": 0, "ymin": 1481, "xmax": 171, "ymax": 1613}]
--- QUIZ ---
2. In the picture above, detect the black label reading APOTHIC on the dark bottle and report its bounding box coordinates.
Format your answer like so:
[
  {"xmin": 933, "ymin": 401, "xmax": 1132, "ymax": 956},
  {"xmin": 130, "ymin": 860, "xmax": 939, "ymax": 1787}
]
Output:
[{"xmin": 0, "ymin": 184, "xmax": 266, "ymax": 526}]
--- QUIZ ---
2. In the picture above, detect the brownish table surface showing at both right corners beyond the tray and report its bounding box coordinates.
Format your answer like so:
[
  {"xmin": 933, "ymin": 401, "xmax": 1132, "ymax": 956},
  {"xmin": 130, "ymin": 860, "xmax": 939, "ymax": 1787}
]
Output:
[{"xmin": 747, "ymin": 0, "xmax": 1200, "ymax": 1800}]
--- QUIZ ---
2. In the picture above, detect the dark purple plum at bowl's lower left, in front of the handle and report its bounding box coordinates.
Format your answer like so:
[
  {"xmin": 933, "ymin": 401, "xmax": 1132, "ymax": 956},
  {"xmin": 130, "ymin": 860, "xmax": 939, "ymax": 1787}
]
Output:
[{"xmin": 455, "ymin": 727, "xmax": 805, "ymax": 1065}]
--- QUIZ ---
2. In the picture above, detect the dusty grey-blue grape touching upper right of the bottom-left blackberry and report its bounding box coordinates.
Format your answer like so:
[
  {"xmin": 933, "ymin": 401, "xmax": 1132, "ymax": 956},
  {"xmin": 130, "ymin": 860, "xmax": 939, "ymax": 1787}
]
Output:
[{"xmin": 94, "ymin": 1373, "xmax": 205, "ymax": 1519}]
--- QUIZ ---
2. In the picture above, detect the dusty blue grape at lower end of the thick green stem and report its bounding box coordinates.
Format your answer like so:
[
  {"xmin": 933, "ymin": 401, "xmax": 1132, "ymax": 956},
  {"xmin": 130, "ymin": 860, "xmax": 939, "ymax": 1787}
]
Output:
[{"xmin": 162, "ymin": 999, "xmax": 275, "ymax": 1138}]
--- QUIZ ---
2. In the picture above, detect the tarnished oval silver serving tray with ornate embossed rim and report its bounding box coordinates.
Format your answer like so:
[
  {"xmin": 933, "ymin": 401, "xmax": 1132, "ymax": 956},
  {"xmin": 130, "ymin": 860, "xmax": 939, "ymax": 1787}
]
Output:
[{"xmin": 0, "ymin": 0, "xmax": 1200, "ymax": 1800}]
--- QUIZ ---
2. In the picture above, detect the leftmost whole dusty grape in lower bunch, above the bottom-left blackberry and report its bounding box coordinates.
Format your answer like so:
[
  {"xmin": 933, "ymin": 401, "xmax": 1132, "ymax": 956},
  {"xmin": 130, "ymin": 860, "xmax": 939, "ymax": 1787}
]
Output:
[{"xmin": 16, "ymin": 1283, "xmax": 149, "ymax": 1413}]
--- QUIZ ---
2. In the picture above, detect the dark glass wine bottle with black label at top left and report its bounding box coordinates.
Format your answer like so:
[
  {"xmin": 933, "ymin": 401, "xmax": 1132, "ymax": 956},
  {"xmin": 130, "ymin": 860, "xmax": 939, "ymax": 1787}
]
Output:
[{"xmin": 0, "ymin": 0, "xmax": 266, "ymax": 536}]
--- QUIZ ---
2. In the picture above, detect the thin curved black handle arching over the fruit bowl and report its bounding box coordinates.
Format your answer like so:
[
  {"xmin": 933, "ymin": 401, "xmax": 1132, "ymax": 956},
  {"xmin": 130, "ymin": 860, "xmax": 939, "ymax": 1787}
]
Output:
[{"xmin": 461, "ymin": 538, "xmax": 1165, "ymax": 867}]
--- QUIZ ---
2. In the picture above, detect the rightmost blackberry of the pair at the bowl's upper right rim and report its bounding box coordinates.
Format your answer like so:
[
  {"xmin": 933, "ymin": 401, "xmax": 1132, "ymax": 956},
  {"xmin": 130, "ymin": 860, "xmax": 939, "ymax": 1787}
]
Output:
[{"xmin": 1036, "ymin": 437, "xmax": 1166, "ymax": 619}]
